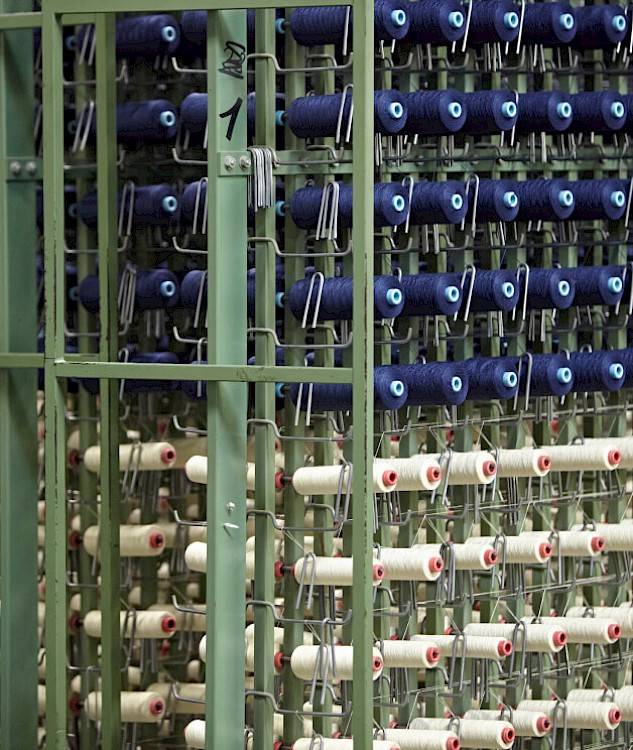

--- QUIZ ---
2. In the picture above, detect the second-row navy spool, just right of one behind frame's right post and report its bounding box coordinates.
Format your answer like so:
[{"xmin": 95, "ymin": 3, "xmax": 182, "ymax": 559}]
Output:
[{"xmin": 404, "ymin": 89, "xmax": 466, "ymax": 135}]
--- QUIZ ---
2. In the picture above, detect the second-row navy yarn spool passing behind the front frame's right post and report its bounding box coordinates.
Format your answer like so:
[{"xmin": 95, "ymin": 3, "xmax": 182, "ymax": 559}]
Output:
[{"xmin": 285, "ymin": 89, "xmax": 407, "ymax": 138}]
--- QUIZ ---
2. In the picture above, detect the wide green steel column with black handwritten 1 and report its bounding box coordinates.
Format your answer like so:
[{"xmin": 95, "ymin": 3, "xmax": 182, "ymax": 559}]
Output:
[{"xmin": 206, "ymin": 11, "xmax": 247, "ymax": 750}]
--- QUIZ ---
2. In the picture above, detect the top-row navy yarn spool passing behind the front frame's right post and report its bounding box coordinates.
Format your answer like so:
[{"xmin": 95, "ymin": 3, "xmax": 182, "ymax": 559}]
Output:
[{"xmin": 290, "ymin": 0, "xmax": 409, "ymax": 47}]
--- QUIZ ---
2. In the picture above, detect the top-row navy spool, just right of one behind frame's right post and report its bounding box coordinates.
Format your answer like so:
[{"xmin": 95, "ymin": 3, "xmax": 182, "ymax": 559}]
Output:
[{"xmin": 407, "ymin": 0, "xmax": 466, "ymax": 44}]
